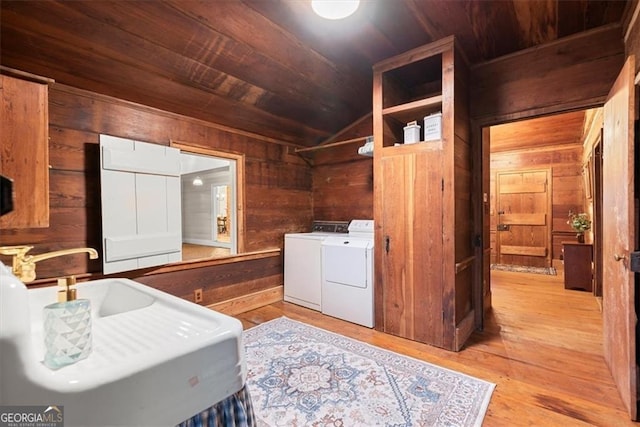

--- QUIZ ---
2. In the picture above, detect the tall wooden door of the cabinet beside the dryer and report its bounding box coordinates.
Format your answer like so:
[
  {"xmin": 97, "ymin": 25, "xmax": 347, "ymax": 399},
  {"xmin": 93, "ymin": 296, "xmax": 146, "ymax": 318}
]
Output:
[{"xmin": 375, "ymin": 153, "xmax": 444, "ymax": 347}]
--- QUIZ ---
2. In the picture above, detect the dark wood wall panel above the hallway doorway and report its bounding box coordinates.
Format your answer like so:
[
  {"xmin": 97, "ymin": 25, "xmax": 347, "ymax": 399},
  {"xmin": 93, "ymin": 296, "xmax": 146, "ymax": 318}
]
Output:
[{"xmin": 471, "ymin": 25, "xmax": 625, "ymax": 124}]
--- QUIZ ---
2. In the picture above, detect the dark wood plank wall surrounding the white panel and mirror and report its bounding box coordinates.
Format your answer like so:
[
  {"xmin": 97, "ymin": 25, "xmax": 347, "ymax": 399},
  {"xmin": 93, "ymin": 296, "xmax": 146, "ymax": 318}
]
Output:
[{"xmin": 0, "ymin": 84, "xmax": 313, "ymax": 304}]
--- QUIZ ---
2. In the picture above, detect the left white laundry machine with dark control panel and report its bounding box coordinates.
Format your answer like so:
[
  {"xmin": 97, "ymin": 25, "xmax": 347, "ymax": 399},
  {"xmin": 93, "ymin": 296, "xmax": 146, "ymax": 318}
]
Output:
[{"xmin": 284, "ymin": 221, "xmax": 348, "ymax": 311}]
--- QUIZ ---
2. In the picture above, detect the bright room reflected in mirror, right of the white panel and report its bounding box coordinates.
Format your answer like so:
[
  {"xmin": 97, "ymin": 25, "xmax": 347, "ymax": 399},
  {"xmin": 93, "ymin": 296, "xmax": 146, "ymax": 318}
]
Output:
[{"xmin": 180, "ymin": 151, "xmax": 237, "ymax": 261}]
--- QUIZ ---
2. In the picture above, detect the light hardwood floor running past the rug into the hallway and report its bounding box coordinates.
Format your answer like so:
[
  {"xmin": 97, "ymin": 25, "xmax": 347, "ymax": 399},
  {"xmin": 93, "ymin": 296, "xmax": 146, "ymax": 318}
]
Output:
[{"xmin": 235, "ymin": 271, "xmax": 640, "ymax": 427}]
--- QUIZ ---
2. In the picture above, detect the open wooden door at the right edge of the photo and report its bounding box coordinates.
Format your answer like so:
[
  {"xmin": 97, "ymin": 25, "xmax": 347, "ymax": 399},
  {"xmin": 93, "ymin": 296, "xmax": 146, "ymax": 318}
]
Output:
[{"xmin": 602, "ymin": 55, "xmax": 637, "ymax": 419}]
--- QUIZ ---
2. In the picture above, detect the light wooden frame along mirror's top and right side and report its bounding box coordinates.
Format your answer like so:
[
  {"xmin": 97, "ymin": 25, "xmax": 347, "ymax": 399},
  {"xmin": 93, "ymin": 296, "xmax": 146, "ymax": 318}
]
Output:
[{"xmin": 169, "ymin": 140, "xmax": 246, "ymax": 257}]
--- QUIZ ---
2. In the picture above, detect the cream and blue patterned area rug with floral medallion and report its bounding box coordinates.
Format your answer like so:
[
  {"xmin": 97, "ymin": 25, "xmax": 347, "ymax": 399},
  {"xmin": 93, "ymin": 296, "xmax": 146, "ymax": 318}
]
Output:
[{"xmin": 244, "ymin": 317, "xmax": 495, "ymax": 427}]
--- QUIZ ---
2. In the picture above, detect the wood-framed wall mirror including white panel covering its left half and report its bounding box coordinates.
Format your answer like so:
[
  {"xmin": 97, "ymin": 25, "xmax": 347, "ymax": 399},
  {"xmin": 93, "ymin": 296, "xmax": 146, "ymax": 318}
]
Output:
[{"xmin": 100, "ymin": 135, "xmax": 244, "ymax": 274}]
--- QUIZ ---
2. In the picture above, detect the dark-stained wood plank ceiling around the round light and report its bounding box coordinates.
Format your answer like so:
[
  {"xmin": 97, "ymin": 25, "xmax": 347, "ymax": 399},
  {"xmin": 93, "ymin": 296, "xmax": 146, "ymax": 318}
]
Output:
[{"xmin": 0, "ymin": 0, "xmax": 627, "ymax": 146}]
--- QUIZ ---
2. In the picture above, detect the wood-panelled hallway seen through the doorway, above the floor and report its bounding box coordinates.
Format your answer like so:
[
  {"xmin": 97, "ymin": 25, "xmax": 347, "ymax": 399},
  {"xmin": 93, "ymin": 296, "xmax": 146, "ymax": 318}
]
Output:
[{"xmin": 483, "ymin": 108, "xmax": 603, "ymax": 284}]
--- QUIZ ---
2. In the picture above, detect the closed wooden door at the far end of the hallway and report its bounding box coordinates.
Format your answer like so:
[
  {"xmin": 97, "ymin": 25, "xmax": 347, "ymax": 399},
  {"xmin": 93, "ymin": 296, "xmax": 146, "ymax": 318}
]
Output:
[{"xmin": 496, "ymin": 169, "xmax": 551, "ymax": 267}]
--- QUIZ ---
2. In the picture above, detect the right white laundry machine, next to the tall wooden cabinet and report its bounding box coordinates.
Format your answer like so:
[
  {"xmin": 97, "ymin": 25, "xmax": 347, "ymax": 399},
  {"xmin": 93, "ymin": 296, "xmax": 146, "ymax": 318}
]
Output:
[{"xmin": 322, "ymin": 219, "xmax": 374, "ymax": 328}]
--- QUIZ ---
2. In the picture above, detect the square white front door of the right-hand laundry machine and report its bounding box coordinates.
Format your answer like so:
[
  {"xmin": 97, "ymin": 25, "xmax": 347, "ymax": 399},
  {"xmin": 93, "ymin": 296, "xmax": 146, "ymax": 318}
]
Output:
[{"xmin": 322, "ymin": 237, "xmax": 372, "ymax": 288}]
